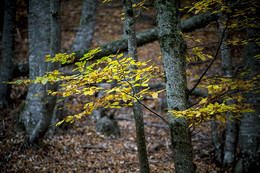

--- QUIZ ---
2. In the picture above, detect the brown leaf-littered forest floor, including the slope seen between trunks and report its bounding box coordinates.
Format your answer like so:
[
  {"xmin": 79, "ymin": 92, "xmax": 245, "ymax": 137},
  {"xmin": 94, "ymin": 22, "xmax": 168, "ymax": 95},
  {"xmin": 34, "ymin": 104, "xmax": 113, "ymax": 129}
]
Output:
[{"xmin": 0, "ymin": 0, "xmax": 244, "ymax": 173}]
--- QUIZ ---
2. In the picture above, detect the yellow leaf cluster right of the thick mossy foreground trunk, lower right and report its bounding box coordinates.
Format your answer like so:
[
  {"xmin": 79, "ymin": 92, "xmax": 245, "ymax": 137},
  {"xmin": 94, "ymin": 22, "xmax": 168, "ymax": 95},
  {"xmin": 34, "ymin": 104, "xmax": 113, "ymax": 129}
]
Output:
[{"xmin": 169, "ymin": 73, "xmax": 260, "ymax": 125}]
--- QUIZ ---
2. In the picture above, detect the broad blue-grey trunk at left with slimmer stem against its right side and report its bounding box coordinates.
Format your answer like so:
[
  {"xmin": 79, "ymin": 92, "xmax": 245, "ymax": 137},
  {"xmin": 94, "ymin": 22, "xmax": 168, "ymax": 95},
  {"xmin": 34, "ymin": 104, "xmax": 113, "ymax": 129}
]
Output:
[{"xmin": 18, "ymin": 0, "xmax": 60, "ymax": 146}]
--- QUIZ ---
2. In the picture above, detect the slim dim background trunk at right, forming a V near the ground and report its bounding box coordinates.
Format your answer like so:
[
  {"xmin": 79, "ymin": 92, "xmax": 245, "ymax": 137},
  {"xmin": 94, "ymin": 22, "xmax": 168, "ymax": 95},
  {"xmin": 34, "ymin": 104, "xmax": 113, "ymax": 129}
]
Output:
[{"xmin": 211, "ymin": 8, "xmax": 238, "ymax": 167}]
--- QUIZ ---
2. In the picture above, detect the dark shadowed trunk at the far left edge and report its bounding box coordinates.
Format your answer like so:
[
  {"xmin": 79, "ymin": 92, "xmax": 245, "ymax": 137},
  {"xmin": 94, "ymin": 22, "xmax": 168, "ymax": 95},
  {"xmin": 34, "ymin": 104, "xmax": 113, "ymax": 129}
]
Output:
[{"xmin": 0, "ymin": 0, "xmax": 16, "ymax": 109}]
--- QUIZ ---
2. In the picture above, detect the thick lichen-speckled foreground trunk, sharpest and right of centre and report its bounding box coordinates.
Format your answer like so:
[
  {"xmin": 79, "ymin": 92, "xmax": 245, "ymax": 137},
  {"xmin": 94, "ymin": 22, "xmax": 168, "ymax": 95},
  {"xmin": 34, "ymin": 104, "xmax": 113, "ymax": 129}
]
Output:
[{"xmin": 156, "ymin": 0, "xmax": 195, "ymax": 173}]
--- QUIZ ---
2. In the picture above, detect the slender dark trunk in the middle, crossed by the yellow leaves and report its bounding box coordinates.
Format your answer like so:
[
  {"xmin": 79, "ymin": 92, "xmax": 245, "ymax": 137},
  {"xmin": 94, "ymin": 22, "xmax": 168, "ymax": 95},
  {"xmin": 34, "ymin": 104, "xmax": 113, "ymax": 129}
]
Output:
[{"xmin": 122, "ymin": 0, "xmax": 150, "ymax": 173}]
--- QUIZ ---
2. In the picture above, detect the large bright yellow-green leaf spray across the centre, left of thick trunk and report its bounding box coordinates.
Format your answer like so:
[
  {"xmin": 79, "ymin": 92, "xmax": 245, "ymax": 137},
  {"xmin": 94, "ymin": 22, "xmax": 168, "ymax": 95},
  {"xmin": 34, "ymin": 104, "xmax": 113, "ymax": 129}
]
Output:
[{"xmin": 33, "ymin": 48, "xmax": 162, "ymax": 125}]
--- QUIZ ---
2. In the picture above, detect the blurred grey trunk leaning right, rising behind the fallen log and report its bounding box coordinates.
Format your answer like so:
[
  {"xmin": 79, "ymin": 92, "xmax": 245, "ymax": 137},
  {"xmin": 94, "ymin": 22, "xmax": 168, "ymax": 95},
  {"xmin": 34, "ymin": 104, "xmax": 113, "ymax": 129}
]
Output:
[{"xmin": 71, "ymin": 0, "xmax": 98, "ymax": 51}]
